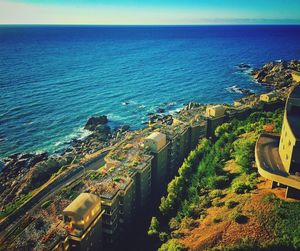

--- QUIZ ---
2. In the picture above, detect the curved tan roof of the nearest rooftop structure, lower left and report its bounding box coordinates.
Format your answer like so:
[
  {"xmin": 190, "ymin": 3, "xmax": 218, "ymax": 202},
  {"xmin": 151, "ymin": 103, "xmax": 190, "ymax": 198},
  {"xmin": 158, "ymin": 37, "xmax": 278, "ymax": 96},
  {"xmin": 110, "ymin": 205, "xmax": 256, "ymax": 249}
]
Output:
[{"xmin": 63, "ymin": 193, "xmax": 101, "ymax": 218}]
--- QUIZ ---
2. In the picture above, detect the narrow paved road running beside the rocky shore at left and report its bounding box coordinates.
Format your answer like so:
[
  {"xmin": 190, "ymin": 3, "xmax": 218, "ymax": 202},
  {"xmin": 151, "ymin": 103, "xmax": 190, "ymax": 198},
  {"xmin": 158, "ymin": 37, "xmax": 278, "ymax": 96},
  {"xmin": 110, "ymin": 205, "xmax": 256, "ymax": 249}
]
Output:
[{"xmin": 0, "ymin": 151, "xmax": 108, "ymax": 243}]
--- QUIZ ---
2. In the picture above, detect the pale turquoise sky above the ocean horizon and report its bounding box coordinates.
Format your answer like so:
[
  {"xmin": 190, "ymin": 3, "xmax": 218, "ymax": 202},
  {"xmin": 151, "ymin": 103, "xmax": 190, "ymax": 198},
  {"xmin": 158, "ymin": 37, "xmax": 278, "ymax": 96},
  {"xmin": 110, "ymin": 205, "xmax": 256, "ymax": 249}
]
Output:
[{"xmin": 0, "ymin": 0, "xmax": 300, "ymax": 25}]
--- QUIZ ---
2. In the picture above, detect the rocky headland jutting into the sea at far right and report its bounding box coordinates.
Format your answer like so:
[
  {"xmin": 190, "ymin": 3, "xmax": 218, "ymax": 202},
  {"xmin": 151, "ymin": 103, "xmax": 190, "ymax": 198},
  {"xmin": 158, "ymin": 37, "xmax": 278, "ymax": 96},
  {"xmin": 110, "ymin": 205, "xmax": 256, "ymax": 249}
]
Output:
[{"xmin": 252, "ymin": 60, "xmax": 300, "ymax": 89}]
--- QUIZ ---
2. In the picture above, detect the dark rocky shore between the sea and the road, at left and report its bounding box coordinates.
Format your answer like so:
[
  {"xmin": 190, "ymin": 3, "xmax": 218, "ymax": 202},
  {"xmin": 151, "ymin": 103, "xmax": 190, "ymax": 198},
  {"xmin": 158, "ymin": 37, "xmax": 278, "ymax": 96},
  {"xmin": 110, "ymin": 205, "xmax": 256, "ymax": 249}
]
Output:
[{"xmin": 0, "ymin": 116, "xmax": 130, "ymax": 210}]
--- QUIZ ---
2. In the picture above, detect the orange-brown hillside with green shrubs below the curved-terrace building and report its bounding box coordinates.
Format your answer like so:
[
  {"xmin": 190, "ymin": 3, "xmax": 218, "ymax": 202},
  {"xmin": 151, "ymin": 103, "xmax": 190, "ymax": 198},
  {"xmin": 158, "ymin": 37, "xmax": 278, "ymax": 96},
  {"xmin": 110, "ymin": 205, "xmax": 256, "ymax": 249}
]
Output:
[{"xmin": 148, "ymin": 110, "xmax": 300, "ymax": 251}]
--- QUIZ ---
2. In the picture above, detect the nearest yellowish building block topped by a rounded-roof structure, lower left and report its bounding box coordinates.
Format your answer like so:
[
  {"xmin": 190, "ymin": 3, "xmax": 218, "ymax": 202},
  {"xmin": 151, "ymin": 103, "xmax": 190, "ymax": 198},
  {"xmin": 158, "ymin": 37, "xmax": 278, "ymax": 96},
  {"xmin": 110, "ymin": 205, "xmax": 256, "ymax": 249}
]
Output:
[{"xmin": 54, "ymin": 193, "xmax": 104, "ymax": 251}]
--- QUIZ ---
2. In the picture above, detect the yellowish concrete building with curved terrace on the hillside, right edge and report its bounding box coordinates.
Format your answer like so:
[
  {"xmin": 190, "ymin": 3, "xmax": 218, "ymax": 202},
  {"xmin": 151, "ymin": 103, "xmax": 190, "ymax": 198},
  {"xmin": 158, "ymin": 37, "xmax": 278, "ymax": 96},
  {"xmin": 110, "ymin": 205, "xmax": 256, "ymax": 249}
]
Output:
[{"xmin": 255, "ymin": 86, "xmax": 300, "ymax": 199}]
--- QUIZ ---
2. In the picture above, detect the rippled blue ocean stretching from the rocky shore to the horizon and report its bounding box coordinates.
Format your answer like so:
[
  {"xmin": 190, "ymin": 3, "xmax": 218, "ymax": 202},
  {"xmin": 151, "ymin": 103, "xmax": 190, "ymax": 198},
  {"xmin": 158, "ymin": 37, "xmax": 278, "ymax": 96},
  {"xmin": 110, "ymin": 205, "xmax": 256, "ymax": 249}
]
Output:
[{"xmin": 0, "ymin": 26, "xmax": 300, "ymax": 157}]
